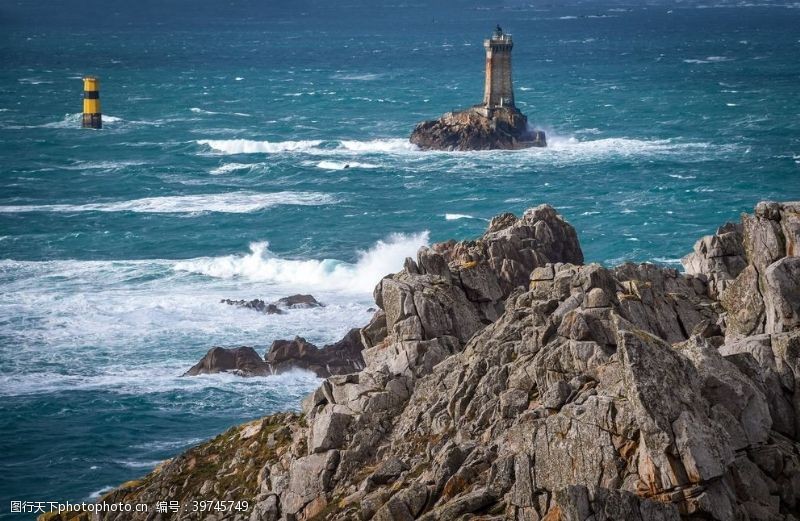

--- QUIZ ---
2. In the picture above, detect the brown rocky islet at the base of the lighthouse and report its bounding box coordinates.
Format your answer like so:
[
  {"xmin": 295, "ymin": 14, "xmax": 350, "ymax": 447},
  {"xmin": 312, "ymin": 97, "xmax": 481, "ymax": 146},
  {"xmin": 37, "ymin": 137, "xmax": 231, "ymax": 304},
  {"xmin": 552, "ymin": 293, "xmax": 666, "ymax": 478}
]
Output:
[{"xmin": 410, "ymin": 107, "xmax": 547, "ymax": 150}]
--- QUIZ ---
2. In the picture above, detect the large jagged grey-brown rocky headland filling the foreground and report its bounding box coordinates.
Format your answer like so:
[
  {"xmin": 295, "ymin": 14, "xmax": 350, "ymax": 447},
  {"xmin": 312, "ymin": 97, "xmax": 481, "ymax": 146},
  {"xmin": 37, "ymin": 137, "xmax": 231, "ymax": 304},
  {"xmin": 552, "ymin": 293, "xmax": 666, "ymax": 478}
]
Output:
[{"xmin": 61, "ymin": 203, "xmax": 800, "ymax": 521}]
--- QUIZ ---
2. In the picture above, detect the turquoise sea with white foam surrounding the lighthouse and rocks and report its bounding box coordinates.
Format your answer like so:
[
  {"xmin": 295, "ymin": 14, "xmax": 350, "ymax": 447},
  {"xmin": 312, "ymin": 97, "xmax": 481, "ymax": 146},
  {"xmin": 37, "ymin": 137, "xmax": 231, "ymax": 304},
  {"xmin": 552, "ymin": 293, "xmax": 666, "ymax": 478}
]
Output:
[{"xmin": 0, "ymin": 0, "xmax": 800, "ymax": 519}]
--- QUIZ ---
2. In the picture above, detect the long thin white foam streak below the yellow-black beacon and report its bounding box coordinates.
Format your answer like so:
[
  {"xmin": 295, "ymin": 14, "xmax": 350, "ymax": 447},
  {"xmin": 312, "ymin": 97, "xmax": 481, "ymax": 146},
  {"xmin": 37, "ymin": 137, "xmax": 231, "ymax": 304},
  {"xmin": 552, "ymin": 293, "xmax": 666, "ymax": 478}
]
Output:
[{"xmin": 0, "ymin": 192, "xmax": 338, "ymax": 213}]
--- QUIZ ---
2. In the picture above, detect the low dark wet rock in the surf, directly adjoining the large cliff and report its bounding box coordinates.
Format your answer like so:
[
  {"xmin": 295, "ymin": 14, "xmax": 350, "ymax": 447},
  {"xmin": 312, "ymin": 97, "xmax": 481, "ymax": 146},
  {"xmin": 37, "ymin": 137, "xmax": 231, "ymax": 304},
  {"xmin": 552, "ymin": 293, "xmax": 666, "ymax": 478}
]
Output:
[{"xmin": 265, "ymin": 328, "xmax": 364, "ymax": 378}]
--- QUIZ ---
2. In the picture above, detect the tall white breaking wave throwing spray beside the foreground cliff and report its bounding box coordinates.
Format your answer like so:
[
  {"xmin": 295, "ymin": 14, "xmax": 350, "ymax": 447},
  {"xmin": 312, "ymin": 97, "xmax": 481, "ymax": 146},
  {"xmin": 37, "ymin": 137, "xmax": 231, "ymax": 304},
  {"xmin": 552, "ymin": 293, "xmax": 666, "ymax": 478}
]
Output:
[{"xmin": 174, "ymin": 232, "xmax": 429, "ymax": 293}]
